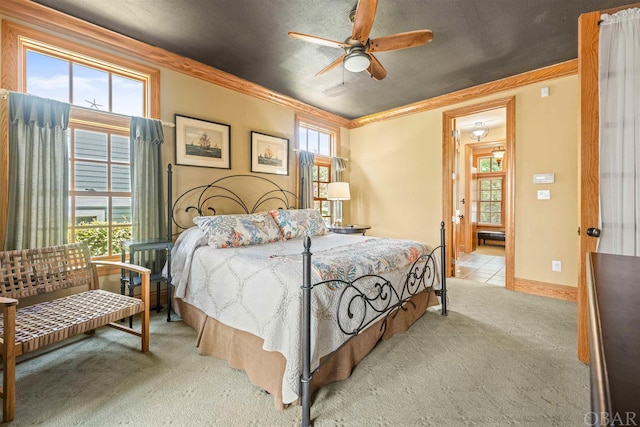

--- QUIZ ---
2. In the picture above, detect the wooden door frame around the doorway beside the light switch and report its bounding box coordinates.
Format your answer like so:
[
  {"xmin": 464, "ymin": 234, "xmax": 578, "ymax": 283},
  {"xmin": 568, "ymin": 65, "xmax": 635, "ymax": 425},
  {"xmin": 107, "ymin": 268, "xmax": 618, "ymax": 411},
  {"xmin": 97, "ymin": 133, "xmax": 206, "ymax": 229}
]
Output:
[{"xmin": 442, "ymin": 96, "xmax": 516, "ymax": 290}]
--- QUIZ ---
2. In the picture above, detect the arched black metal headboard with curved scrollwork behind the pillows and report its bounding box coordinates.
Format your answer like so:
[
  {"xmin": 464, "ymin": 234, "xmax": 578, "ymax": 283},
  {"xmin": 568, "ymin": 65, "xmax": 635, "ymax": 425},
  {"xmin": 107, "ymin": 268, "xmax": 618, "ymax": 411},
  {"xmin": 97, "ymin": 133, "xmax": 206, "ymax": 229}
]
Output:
[{"xmin": 167, "ymin": 163, "xmax": 298, "ymax": 240}]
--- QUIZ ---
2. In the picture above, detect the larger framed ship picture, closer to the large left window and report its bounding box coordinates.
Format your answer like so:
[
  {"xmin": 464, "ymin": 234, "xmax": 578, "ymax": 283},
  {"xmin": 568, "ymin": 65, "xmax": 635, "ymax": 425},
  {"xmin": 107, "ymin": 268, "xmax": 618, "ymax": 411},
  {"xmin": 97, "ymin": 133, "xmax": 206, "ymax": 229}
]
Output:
[{"xmin": 175, "ymin": 114, "xmax": 231, "ymax": 169}]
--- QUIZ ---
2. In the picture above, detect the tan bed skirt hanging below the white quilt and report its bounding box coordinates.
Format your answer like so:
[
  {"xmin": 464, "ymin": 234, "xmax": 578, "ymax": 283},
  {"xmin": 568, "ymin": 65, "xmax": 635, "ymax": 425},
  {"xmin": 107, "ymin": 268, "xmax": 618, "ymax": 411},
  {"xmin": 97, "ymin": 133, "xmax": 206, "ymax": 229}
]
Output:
[{"xmin": 174, "ymin": 291, "xmax": 439, "ymax": 409}]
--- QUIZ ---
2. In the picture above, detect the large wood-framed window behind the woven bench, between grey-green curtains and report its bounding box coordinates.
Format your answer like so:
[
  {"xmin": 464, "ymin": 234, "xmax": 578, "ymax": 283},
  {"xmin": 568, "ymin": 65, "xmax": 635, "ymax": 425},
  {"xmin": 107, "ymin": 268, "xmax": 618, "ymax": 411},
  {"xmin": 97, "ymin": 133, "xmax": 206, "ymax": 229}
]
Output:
[{"xmin": 14, "ymin": 29, "xmax": 159, "ymax": 256}]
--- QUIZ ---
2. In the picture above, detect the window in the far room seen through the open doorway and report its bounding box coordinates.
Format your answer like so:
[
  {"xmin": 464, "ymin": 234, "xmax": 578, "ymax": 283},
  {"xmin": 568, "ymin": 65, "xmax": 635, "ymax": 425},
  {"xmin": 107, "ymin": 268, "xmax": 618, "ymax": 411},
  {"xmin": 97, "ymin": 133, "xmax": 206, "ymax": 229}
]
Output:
[{"xmin": 476, "ymin": 156, "xmax": 504, "ymax": 226}]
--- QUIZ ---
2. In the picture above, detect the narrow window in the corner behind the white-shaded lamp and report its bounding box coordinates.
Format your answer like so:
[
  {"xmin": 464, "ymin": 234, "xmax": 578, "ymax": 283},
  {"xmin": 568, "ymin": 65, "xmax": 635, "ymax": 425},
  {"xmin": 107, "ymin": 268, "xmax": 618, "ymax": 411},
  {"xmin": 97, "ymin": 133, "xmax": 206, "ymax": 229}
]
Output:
[{"xmin": 296, "ymin": 118, "xmax": 338, "ymax": 224}]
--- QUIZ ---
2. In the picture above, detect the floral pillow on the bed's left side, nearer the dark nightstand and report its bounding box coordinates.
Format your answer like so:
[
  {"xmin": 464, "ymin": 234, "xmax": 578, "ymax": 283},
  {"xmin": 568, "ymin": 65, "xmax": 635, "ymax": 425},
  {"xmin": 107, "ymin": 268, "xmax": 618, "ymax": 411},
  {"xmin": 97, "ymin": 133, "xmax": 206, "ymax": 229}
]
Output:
[{"xmin": 193, "ymin": 212, "xmax": 284, "ymax": 248}]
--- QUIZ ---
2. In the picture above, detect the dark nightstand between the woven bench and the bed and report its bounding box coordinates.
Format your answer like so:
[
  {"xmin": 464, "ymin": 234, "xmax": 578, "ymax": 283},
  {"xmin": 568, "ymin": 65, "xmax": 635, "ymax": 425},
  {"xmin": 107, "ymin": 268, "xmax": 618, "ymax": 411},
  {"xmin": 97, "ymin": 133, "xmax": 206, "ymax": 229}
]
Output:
[{"xmin": 120, "ymin": 239, "xmax": 173, "ymax": 324}]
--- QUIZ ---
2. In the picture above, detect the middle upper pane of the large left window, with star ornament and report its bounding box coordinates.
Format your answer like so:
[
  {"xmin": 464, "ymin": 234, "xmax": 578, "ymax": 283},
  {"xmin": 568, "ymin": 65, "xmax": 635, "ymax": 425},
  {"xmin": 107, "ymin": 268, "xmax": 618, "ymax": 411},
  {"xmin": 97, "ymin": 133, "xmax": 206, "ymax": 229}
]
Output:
[{"xmin": 73, "ymin": 64, "xmax": 110, "ymax": 111}]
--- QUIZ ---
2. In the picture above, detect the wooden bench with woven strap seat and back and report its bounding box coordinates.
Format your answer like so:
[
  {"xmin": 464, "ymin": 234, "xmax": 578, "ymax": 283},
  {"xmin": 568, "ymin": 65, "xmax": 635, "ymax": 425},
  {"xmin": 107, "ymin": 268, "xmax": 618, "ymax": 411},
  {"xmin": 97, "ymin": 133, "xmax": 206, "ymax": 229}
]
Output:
[{"xmin": 0, "ymin": 243, "xmax": 150, "ymax": 422}]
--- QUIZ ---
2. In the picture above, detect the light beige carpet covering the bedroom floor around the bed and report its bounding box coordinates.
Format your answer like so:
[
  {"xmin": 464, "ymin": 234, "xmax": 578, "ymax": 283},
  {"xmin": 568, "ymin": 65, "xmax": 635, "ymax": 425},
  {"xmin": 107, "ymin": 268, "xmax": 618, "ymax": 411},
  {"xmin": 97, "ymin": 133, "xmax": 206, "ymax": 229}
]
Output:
[{"xmin": 7, "ymin": 279, "xmax": 590, "ymax": 427}]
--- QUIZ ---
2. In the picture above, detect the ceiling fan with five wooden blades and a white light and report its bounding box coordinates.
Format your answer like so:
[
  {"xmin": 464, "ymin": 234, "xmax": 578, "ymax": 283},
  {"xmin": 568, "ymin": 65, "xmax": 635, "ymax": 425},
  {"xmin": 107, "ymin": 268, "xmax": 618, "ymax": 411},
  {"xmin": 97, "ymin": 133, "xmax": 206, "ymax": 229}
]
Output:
[{"xmin": 289, "ymin": 0, "xmax": 433, "ymax": 80}]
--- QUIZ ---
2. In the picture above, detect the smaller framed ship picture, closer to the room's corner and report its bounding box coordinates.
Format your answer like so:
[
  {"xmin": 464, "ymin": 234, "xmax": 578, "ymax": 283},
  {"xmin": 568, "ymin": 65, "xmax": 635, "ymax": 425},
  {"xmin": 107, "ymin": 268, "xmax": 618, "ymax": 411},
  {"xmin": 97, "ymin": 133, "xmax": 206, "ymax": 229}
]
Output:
[{"xmin": 251, "ymin": 131, "xmax": 289, "ymax": 175}]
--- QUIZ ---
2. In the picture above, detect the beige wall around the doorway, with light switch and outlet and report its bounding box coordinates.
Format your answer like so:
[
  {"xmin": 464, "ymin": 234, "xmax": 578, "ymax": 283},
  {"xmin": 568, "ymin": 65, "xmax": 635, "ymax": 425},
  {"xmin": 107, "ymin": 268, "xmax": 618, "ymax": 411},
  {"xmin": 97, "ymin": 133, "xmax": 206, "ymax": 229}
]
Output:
[{"xmin": 350, "ymin": 76, "xmax": 579, "ymax": 286}]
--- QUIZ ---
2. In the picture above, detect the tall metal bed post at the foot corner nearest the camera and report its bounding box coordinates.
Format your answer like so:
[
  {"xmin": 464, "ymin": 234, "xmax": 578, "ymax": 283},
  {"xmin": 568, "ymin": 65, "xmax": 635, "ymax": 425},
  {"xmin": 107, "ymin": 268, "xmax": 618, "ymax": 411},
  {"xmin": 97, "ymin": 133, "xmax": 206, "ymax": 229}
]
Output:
[{"xmin": 300, "ymin": 237, "xmax": 311, "ymax": 427}]
